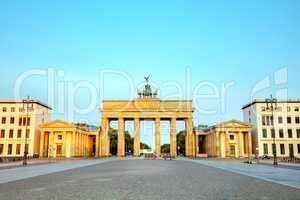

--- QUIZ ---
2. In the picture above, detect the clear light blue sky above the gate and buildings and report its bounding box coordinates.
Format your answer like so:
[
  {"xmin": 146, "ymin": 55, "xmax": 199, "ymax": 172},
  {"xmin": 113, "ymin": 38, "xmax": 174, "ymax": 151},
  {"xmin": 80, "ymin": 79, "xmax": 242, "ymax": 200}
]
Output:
[{"xmin": 0, "ymin": 0, "xmax": 300, "ymax": 148}]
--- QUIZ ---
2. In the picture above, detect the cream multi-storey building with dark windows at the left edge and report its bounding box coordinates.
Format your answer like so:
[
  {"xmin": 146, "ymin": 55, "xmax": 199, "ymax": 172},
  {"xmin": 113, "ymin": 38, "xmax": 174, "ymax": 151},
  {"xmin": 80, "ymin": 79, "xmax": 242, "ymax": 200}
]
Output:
[{"xmin": 0, "ymin": 100, "xmax": 51, "ymax": 159}]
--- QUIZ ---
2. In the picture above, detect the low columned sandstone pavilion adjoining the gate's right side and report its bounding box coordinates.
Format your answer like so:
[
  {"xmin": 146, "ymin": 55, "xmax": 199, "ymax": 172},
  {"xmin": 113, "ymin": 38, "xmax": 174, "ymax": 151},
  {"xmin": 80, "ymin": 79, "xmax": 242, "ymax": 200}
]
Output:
[{"xmin": 195, "ymin": 120, "xmax": 252, "ymax": 158}]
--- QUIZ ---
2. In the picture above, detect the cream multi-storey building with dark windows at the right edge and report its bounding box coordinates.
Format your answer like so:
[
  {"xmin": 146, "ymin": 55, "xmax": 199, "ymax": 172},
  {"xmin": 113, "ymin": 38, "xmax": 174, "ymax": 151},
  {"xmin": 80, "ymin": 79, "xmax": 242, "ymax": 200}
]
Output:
[{"xmin": 242, "ymin": 100, "xmax": 300, "ymax": 157}]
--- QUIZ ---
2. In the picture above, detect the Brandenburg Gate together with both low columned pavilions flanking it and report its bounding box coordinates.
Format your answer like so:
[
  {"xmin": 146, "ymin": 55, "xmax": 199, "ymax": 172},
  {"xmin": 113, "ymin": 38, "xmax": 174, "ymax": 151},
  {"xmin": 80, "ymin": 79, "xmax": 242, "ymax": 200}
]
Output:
[{"xmin": 40, "ymin": 79, "xmax": 252, "ymax": 158}]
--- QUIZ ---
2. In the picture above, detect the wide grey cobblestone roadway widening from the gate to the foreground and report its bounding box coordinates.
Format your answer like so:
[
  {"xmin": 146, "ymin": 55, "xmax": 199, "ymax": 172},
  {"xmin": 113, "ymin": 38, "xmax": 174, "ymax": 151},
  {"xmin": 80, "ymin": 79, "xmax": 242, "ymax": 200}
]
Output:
[{"xmin": 0, "ymin": 160, "xmax": 300, "ymax": 200}]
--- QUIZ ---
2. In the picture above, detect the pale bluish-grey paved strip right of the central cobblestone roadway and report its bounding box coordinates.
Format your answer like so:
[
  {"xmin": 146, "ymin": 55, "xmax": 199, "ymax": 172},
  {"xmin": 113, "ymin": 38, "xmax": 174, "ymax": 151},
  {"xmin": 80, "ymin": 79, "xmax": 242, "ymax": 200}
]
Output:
[{"xmin": 190, "ymin": 159, "xmax": 300, "ymax": 189}]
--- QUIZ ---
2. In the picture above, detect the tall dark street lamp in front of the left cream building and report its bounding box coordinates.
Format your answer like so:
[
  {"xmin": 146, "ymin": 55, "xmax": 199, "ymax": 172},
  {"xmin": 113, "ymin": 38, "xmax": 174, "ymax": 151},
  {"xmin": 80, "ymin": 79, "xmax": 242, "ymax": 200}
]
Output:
[{"xmin": 23, "ymin": 96, "xmax": 33, "ymax": 166}]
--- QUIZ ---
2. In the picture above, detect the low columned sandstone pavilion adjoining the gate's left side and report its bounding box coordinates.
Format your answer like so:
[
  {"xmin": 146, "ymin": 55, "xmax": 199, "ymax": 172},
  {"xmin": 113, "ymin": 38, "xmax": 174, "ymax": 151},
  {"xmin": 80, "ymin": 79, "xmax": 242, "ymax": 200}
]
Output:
[{"xmin": 40, "ymin": 120, "xmax": 99, "ymax": 158}]
